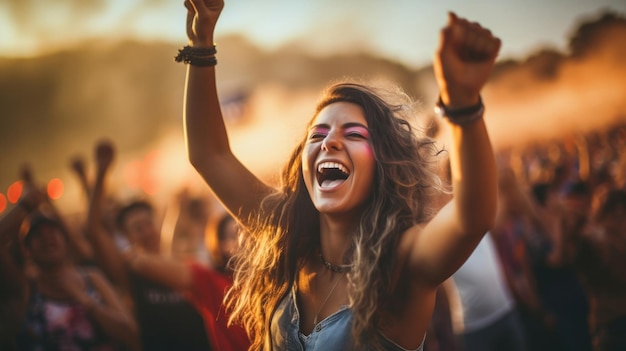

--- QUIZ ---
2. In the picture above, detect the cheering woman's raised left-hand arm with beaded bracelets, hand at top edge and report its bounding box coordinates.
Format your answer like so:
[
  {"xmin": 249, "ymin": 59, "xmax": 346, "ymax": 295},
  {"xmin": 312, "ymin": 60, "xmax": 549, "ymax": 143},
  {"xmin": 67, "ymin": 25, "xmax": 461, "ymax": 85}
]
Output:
[{"xmin": 184, "ymin": 0, "xmax": 272, "ymax": 226}]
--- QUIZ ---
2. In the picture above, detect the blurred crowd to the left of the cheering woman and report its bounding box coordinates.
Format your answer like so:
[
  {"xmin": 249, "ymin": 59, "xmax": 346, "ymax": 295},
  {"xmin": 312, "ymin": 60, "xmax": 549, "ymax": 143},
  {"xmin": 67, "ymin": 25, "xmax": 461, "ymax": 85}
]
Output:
[{"xmin": 0, "ymin": 140, "xmax": 249, "ymax": 351}]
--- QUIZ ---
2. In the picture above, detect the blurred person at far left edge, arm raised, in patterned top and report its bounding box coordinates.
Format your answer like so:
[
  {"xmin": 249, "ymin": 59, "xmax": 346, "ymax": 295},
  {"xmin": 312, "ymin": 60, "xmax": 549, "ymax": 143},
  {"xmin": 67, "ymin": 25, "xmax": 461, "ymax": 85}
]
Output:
[{"xmin": 0, "ymin": 168, "xmax": 137, "ymax": 351}]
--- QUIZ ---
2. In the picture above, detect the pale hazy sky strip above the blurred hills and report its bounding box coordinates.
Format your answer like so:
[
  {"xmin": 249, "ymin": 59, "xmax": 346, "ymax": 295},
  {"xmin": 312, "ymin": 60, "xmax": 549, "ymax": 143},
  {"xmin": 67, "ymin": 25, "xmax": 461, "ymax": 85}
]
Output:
[{"xmin": 0, "ymin": 0, "xmax": 626, "ymax": 67}]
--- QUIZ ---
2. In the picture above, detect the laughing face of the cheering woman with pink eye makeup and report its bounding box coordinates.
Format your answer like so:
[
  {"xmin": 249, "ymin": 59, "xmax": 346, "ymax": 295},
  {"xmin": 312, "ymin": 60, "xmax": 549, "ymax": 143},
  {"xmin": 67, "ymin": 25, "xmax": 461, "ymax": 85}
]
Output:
[{"xmin": 302, "ymin": 102, "xmax": 375, "ymax": 213}]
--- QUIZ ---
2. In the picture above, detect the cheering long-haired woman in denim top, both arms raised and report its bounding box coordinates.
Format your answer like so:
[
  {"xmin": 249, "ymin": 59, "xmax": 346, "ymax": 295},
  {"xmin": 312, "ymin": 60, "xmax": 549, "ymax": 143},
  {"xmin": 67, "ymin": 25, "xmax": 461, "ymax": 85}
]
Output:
[{"xmin": 177, "ymin": 0, "xmax": 500, "ymax": 350}]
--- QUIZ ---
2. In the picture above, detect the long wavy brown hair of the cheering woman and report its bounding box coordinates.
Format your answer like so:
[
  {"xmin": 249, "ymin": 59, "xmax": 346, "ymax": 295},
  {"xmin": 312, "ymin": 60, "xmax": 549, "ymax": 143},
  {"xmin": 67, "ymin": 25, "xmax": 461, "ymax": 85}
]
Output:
[{"xmin": 226, "ymin": 82, "xmax": 444, "ymax": 350}]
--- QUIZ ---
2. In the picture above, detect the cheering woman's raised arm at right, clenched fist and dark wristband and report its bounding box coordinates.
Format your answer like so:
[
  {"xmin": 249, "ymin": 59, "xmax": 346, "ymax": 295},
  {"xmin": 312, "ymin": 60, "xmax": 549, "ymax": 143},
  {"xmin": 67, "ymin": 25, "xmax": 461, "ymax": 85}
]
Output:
[{"xmin": 409, "ymin": 13, "xmax": 501, "ymax": 286}]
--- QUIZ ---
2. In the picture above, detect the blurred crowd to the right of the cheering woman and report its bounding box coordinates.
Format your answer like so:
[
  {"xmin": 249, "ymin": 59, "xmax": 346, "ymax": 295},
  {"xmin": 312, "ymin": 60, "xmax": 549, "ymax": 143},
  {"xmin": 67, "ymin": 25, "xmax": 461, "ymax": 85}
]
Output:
[{"xmin": 426, "ymin": 124, "xmax": 626, "ymax": 351}]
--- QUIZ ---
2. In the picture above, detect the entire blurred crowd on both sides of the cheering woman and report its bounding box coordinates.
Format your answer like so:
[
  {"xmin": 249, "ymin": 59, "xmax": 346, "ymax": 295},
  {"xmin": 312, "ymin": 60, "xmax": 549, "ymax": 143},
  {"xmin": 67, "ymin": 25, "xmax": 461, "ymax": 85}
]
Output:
[{"xmin": 0, "ymin": 119, "xmax": 626, "ymax": 351}]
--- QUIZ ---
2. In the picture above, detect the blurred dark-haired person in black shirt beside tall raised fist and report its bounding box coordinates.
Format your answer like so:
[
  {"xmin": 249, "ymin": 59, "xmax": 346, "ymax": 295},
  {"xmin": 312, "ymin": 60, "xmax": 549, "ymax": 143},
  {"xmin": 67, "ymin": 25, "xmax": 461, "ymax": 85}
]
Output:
[{"xmin": 86, "ymin": 141, "xmax": 211, "ymax": 351}]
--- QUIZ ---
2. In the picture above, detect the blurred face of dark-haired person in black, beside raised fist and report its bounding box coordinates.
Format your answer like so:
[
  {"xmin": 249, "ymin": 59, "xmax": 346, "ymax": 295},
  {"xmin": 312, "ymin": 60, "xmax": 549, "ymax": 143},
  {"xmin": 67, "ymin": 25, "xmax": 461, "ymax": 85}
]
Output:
[{"xmin": 122, "ymin": 208, "xmax": 161, "ymax": 253}]
